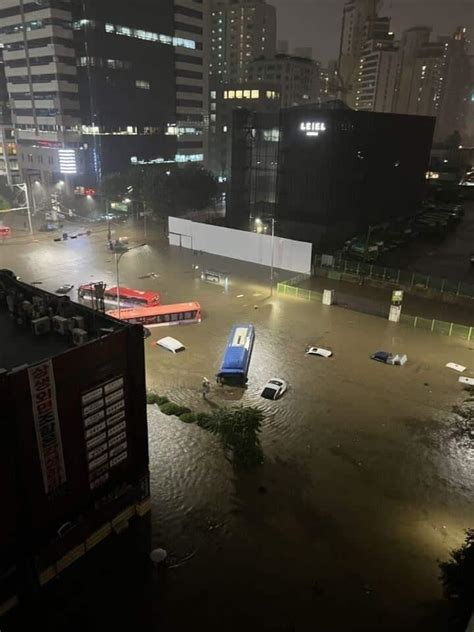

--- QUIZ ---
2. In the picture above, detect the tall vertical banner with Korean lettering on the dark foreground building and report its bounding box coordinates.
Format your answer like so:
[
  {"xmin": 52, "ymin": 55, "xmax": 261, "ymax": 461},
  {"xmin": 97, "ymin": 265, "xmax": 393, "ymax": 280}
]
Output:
[{"xmin": 28, "ymin": 360, "xmax": 66, "ymax": 494}]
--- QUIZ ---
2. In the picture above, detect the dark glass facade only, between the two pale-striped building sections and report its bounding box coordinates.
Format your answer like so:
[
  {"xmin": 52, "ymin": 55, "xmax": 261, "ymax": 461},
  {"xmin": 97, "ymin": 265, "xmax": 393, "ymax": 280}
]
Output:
[{"xmin": 73, "ymin": 0, "xmax": 177, "ymax": 177}]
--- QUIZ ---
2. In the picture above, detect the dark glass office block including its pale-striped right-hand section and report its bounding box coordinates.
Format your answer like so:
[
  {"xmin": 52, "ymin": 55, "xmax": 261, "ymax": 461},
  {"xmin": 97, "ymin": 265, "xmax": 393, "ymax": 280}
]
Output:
[{"xmin": 73, "ymin": 0, "xmax": 203, "ymax": 183}]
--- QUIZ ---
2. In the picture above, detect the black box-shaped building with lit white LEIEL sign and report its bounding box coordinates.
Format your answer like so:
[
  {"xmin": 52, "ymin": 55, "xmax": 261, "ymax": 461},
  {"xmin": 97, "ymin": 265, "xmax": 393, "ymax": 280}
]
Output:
[{"xmin": 228, "ymin": 102, "xmax": 434, "ymax": 248}]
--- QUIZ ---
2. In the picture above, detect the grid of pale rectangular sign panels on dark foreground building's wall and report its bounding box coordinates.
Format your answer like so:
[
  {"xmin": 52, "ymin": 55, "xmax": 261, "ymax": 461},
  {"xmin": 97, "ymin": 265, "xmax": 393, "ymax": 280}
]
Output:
[{"xmin": 81, "ymin": 377, "xmax": 128, "ymax": 489}]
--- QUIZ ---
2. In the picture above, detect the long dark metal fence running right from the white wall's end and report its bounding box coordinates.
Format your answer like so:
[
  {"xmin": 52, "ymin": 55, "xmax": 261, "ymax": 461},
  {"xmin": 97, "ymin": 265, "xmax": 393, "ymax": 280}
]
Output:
[{"xmin": 314, "ymin": 255, "xmax": 474, "ymax": 299}]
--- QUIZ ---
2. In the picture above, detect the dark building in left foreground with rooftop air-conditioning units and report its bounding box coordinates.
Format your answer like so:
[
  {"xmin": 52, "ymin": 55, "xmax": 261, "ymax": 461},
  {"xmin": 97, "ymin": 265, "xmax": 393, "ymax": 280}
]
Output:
[{"xmin": 0, "ymin": 270, "xmax": 149, "ymax": 614}]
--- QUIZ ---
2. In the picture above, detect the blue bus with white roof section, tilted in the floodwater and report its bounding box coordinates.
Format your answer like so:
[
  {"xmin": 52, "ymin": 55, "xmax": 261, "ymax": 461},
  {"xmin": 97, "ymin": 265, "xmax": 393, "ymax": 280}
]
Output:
[{"xmin": 216, "ymin": 325, "xmax": 255, "ymax": 384}]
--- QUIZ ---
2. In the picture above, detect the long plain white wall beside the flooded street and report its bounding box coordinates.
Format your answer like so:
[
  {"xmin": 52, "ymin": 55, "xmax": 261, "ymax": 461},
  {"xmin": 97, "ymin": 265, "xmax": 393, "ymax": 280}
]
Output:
[{"xmin": 168, "ymin": 217, "xmax": 312, "ymax": 274}]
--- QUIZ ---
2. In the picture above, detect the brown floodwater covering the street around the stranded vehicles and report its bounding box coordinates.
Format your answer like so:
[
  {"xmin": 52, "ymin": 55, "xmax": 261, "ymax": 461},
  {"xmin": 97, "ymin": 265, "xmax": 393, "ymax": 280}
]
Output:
[{"xmin": 0, "ymin": 229, "xmax": 474, "ymax": 632}]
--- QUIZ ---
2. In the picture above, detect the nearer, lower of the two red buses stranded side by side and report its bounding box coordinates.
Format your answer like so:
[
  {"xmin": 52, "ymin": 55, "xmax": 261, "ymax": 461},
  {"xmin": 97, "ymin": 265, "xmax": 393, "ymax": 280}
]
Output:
[{"xmin": 107, "ymin": 302, "xmax": 202, "ymax": 327}]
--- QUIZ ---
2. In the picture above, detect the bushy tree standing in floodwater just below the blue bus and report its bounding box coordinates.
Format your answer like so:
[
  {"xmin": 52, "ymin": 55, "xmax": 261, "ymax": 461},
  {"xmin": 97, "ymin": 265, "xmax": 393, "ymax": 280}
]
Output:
[{"xmin": 207, "ymin": 408, "xmax": 264, "ymax": 469}]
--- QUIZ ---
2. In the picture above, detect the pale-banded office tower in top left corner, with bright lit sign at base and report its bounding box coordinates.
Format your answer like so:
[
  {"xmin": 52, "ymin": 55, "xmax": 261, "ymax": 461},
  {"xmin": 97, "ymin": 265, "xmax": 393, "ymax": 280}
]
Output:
[{"xmin": 0, "ymin": 0, "xmax": 84, "ymax": 194}]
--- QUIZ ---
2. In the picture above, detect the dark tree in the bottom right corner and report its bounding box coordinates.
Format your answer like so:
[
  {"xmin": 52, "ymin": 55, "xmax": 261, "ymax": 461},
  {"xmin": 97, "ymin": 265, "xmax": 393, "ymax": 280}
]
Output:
[{"xmin": 439, "ymin": 529, "xmax": 474, "ymax": 632}]
